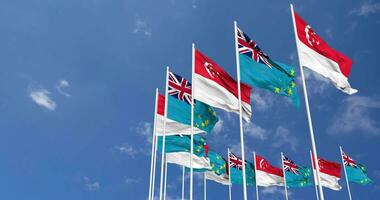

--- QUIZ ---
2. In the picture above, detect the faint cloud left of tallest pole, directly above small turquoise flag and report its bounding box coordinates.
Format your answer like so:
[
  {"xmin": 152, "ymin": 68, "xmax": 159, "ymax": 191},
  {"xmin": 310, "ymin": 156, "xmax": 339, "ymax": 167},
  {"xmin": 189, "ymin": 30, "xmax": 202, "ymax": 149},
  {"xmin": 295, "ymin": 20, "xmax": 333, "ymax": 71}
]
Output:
[{"xmin": 272, "ymin": 126, "xmax": 299, "ymax": 151}]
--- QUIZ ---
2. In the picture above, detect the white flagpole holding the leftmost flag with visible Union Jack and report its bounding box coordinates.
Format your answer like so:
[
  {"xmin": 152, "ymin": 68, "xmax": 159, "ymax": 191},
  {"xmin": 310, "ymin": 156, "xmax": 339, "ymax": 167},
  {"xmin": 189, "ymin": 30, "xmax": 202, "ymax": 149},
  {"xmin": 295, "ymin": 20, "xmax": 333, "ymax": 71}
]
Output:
[{"xmin": 160, "ymin": 67, "xmax": 169, "ymax": 200}]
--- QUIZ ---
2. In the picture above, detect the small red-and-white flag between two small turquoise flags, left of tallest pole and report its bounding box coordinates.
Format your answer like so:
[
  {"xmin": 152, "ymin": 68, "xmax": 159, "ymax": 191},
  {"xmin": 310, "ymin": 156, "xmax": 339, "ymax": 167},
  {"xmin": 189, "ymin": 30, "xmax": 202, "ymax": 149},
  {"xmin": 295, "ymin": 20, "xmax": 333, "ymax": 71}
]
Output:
[{"xmin": 255, "ymin": 155, "xmax": 284, "ymax": 187}]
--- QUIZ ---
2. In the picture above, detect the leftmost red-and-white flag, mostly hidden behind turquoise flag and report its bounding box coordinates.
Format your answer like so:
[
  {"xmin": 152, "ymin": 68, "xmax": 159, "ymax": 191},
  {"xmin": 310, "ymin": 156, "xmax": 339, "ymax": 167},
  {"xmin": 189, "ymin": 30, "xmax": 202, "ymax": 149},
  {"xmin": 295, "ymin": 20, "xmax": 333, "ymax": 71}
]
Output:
[{"xmin": 156, "ymin": 94, "xmax": 204, "ymax": 136}]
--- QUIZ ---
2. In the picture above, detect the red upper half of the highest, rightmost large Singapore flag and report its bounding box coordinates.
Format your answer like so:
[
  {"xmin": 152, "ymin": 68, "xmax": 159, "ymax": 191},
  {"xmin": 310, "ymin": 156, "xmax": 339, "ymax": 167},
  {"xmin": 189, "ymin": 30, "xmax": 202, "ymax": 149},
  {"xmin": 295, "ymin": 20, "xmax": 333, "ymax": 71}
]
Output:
[{"xmin": 294, "ymin": 12, "xmax": 352, "ymax": 78}]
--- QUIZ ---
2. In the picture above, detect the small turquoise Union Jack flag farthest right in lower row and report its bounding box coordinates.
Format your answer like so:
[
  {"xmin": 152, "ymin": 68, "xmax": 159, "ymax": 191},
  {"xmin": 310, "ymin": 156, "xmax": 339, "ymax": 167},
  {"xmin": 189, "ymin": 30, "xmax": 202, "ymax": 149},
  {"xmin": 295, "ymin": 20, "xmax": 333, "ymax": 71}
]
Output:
[{"xmin": 342, "ymin": 151, "xmax": 372, "ymax": 185}]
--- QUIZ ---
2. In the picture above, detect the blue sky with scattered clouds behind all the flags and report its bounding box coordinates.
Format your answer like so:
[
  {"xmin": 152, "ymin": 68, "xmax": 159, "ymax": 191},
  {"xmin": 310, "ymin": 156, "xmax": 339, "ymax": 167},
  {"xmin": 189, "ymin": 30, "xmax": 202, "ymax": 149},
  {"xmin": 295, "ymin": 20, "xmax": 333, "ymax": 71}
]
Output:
[{"xmin": 0, "ymin": 0, "xmax": 380, "ymax": 200}]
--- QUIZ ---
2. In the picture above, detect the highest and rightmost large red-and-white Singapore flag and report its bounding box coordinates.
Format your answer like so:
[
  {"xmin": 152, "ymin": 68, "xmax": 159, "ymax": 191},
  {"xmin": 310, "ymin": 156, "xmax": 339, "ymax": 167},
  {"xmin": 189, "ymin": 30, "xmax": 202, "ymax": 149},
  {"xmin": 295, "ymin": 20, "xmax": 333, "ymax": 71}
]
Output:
[{"xmin": 293, "ymin": 9, "xmax": 357, "ymax": 94}]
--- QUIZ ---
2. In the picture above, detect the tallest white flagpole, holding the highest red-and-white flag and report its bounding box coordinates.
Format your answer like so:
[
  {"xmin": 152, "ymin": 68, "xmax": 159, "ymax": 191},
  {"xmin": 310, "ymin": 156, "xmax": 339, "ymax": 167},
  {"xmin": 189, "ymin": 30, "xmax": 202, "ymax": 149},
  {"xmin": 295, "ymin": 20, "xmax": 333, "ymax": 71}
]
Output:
[{"xmin": 290, "ymin": 4, "xmax": 324, "ymax": 200}]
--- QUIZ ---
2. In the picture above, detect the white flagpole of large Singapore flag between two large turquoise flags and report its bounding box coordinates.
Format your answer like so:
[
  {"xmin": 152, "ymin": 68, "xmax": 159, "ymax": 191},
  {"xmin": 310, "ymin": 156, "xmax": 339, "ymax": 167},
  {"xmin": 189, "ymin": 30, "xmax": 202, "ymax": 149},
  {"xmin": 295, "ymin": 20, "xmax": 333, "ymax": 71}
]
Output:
[{"xmin": 189, "ymin": 43, "xmax": 195, "ymax": 200}]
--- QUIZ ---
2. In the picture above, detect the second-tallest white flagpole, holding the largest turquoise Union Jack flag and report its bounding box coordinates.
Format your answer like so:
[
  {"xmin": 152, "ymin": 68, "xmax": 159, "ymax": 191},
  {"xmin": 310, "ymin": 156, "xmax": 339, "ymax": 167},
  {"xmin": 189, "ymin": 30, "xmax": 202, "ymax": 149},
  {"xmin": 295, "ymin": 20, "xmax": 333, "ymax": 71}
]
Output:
[{"xmin": 234, "ymin": 21, "xmax": 247, "ymax": 200}]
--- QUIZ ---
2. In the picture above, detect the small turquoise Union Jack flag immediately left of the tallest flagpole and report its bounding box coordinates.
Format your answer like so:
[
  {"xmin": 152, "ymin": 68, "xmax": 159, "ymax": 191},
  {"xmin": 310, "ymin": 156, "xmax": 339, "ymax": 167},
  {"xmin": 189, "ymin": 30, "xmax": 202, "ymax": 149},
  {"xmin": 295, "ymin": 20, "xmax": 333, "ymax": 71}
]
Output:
[{"xmin": 282, "ymin": 156, "xmax": 313, "ymax": 188}]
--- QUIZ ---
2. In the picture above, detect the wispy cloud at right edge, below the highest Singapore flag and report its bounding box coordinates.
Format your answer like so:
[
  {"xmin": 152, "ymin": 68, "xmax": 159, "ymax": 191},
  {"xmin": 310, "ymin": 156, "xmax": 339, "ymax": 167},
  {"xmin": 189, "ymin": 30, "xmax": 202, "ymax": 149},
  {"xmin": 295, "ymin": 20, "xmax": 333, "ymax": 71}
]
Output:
[{"xmin": 327, "ymin": 96, "xmax": 380, "ymax": 135}]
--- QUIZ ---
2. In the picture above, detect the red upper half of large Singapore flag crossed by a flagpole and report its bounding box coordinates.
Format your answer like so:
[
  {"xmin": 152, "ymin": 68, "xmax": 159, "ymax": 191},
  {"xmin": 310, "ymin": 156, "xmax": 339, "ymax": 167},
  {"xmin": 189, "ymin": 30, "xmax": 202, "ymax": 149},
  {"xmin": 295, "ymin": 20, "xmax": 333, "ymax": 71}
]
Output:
[{"xmin": 195, "ymin": 49, "xmax": 251, "ymax": 104}]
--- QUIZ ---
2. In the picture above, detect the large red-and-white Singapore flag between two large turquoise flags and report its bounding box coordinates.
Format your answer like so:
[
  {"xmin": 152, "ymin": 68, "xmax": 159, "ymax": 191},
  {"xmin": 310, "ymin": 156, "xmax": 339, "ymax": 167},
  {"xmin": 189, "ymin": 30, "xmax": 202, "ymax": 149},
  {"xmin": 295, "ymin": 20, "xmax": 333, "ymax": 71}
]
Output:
[{"xmin": 193, "ymin": 50, "xmax": 252, "ymax": 121}]
